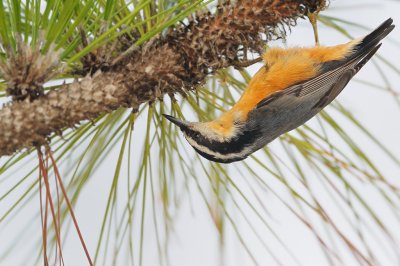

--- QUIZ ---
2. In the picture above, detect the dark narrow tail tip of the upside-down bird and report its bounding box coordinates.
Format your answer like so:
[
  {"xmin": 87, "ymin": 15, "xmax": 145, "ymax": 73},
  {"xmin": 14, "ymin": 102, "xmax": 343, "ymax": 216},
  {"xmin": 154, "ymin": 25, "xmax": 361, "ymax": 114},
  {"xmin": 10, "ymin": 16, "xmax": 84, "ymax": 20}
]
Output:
[{"xmin": 350, "ymin": 18, "xmax": 394, "ymax": 58}]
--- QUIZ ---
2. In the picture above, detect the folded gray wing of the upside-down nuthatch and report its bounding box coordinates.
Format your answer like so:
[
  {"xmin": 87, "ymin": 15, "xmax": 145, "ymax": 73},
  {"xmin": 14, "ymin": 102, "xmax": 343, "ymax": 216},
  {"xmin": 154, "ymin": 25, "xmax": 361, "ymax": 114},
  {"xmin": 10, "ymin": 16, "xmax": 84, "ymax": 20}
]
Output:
[{"xmin": 246, "ymin": 44, "xmax": 380, "ymax": 148}]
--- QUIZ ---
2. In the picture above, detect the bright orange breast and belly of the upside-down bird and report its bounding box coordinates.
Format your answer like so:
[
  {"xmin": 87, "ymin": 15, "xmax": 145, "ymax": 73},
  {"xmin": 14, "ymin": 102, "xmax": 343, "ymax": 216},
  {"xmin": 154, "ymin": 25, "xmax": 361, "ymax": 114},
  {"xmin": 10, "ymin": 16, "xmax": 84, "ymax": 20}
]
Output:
[{"xmin": 209, "ymin": 41, "xmax": 357, "ymax": 135}]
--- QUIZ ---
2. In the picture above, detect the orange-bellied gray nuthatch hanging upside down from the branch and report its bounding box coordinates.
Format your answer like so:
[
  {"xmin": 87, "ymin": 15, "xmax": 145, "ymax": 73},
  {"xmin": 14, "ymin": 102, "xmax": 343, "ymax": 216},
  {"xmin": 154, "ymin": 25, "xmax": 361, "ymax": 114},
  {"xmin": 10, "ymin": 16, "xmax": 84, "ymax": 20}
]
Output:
[{"xmin": 164, "ymin": 18, "xmax": 395, "ymax": 163}]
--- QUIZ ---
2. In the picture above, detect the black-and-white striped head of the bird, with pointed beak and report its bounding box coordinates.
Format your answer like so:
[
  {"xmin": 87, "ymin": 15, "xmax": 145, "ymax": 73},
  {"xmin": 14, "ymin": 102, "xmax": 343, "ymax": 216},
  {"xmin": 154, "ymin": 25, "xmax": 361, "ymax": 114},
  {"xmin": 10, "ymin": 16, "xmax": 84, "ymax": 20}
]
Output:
[{"xmin": 164, "ymin": 115, "xmax": 258, "ymax": 163}]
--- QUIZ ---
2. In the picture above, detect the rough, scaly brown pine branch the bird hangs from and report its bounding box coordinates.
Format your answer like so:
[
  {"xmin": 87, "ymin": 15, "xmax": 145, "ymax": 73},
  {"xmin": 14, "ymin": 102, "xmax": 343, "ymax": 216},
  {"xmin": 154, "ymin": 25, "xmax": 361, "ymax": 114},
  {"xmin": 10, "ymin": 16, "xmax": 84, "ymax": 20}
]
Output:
[{"xmin": 0, "ymin": 0, "xmax": 319, "ymax": 156}]
